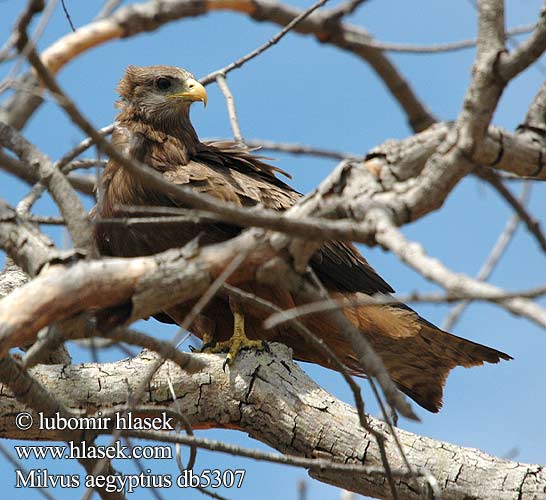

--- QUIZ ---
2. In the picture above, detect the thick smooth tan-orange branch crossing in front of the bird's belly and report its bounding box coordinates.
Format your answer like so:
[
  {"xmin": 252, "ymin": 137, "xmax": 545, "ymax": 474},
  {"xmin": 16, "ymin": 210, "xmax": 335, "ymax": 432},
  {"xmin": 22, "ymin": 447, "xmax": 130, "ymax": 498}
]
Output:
[{"xmin": 0, "ymin": 230, "xmax": 268, "ymax": 357}]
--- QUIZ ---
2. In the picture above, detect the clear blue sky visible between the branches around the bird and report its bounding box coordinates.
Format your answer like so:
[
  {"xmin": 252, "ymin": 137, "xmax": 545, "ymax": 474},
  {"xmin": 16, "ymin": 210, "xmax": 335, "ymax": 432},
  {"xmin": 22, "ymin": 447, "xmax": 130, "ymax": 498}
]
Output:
[{"xmin": 0, "ymin": 0, "xmax": 546, "ymax": 500}]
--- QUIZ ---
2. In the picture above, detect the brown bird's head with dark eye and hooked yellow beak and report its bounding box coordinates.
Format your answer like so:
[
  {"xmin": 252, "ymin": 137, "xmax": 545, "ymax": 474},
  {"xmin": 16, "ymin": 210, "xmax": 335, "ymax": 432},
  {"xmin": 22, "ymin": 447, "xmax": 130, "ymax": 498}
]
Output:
[{"xmin": 117, "ymin": 66, "xmax": 207, "ymax": 122}]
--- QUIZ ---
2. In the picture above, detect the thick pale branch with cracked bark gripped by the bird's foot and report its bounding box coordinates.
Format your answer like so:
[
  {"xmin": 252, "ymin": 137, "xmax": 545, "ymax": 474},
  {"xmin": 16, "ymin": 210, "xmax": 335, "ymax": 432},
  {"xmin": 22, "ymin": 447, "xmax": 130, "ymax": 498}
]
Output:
[{"xmin": 0, "ymin": 344, "xmax": 546, "ymax": 500}]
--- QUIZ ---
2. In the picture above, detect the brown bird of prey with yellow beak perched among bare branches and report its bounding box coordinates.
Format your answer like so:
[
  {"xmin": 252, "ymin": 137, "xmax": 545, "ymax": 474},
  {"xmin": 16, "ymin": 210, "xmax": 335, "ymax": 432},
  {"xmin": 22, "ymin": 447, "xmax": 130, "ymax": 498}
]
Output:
[{"xmin": 95, "ymin": 66, "xmax": 511, "ymax": 412}]
